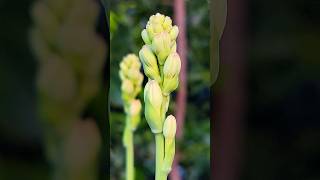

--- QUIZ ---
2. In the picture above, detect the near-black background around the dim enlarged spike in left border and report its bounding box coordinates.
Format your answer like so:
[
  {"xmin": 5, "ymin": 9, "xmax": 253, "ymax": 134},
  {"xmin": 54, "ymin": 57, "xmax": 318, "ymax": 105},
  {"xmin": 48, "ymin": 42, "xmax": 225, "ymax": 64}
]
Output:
[{"xmin": 0, "ymin": 0, "xmax": 109, "ymax": 180}]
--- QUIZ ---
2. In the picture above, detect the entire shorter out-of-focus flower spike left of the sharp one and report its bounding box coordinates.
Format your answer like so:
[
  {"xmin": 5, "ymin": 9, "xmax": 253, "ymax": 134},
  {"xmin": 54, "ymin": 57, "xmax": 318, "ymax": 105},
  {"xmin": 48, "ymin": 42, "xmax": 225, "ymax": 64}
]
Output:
[{"xmin": 119, "ymin": 54, "xmax": 143, "ymax": 180}]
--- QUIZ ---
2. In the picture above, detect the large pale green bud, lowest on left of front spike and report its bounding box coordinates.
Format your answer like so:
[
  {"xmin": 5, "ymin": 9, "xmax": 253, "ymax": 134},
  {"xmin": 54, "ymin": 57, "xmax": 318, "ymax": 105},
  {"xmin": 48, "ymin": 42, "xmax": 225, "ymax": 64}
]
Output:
[{"xmin": 144, "ymin": 80, "xmax": 163, "ymax": 133}]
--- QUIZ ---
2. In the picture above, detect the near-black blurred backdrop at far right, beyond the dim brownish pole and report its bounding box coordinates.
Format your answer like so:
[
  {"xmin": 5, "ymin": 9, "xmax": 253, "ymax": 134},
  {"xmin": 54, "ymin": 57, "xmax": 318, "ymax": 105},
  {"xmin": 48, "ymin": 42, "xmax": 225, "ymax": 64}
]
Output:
[{"xmin": 241, "ymin": 0, "xmax": 320, "ymax": 180}]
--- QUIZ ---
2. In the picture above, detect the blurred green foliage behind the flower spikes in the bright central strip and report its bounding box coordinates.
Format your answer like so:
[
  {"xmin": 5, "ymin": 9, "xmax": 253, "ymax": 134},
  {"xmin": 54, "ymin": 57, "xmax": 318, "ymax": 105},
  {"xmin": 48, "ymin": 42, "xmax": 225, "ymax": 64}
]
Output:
[{"xmin": 110, "ymin": 0, "xmax": 210, "ymax": 179}]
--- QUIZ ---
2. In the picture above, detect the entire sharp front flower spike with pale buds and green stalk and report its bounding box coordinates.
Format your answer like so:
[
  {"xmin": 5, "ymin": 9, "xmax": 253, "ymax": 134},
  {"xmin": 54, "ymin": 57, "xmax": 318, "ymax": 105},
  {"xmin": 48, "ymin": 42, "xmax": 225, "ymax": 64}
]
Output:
[{"xmin": 139, "ymin": 13, "xmax": 181, "ymax": 180}]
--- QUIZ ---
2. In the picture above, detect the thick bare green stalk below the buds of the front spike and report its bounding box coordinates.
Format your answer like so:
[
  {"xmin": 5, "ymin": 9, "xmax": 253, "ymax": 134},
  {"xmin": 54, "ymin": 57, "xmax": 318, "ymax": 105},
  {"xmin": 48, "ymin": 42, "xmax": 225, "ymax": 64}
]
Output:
[{"xmin": 155, "ymin": 133, "xmax": 164, "ymax": 180}]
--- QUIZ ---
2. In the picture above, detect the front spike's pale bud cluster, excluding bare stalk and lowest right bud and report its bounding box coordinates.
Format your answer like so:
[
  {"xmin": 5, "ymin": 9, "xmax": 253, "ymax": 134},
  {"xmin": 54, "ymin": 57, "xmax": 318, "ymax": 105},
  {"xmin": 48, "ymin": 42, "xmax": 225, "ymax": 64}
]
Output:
[{"xmin": 139, "ymin": 13, "xmax": 181, "ymax": 133}]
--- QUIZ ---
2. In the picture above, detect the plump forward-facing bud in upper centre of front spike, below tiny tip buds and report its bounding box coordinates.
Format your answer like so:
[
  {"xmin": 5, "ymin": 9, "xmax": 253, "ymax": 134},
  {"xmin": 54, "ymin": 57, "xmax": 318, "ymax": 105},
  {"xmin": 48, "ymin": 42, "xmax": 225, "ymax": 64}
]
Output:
[{"xmin": 152, "ymin": 32, "xmax": 171, "ymax": 65}]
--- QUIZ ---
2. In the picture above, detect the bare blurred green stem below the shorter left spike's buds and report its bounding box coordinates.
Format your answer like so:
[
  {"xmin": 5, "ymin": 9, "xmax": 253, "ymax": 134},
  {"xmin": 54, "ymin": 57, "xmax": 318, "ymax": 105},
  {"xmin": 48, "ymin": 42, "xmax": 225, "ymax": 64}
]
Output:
[{"xmin": 126, "ymin": 129, "xmax": 134, "ymax": 180}]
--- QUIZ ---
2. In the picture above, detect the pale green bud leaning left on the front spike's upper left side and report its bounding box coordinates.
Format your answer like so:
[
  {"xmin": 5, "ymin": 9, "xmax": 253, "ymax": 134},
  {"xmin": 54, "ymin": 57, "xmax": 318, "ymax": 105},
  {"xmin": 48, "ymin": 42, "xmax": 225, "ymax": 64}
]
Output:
[{"xmin": 139, "ymin": 45, "xmax": 161, "ymax": 82}]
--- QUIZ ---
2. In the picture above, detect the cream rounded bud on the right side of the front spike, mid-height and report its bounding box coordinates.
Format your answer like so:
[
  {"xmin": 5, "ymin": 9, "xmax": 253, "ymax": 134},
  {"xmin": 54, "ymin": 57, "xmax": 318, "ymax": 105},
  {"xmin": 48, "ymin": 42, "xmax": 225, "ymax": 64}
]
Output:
[{"xmin": 163, "ymin": 53, "xmax": 181, "ymax": 78}]
